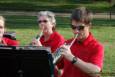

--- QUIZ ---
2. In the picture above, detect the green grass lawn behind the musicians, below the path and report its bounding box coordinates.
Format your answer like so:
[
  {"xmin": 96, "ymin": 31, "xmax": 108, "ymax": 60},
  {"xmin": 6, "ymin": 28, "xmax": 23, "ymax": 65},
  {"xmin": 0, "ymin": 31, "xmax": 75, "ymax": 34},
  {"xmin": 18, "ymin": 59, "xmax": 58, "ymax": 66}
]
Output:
[{"xmin": 5, "ymin": 16, "xmax": 115, "ymax": 77}]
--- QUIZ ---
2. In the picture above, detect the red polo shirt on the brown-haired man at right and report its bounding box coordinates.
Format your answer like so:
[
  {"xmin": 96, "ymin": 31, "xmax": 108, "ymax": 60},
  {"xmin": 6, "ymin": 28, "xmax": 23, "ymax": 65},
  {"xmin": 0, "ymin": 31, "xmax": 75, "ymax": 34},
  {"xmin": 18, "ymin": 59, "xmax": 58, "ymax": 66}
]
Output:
[{"xmin": 62, "ymin": 33, "xmax": 104, "ymax": 77}]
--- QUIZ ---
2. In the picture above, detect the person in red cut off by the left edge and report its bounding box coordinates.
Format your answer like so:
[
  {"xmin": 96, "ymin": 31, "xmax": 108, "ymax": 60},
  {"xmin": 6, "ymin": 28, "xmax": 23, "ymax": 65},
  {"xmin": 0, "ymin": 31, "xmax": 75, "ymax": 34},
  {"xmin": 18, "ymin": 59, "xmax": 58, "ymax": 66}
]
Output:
[{"xmin": 0, "ymin": 16, "xmax": 19, "ymax": 46}]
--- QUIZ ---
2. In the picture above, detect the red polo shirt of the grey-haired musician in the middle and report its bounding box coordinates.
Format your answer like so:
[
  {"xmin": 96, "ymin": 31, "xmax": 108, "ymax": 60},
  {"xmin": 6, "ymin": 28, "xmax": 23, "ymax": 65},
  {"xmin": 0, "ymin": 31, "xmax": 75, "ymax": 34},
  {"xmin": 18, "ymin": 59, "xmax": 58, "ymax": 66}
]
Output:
[{"xmin": 40, "ymin": 32, "xmax": 65, "ymax": 53}]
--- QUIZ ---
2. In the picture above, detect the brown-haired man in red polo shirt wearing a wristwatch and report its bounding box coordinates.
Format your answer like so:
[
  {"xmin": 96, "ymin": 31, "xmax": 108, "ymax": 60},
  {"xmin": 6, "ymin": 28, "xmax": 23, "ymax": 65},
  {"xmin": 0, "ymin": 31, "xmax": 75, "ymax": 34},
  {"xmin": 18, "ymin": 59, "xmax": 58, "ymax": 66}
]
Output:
[{"xmin": 59, "ymin": 7, "xmax": 104, "ymax": 77}]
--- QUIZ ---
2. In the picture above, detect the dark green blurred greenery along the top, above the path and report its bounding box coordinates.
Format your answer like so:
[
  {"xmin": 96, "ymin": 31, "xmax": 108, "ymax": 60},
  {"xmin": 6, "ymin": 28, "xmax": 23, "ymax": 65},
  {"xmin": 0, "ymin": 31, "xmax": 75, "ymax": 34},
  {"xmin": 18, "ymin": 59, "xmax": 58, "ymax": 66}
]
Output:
[{"xmin": 0, "ymin": 0, "xmax": 115, "ymax": 12}]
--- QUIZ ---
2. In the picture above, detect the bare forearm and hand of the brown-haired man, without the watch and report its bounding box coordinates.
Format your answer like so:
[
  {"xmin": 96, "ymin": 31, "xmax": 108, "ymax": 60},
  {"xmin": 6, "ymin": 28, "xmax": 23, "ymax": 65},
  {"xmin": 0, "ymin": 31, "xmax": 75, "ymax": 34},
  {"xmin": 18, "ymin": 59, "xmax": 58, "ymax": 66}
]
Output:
[{"xmin": 62, "ymin": 46, "xmax": 101, "ymax": 77}]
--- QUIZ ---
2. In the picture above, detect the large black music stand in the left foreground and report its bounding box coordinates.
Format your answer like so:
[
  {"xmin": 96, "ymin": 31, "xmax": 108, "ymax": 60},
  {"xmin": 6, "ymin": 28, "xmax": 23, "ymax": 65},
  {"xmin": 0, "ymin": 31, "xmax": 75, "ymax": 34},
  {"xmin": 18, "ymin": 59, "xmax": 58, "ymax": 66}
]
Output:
[{"xmin": 0, "ymin": 47, "xmax": 54, "ymax": 77}]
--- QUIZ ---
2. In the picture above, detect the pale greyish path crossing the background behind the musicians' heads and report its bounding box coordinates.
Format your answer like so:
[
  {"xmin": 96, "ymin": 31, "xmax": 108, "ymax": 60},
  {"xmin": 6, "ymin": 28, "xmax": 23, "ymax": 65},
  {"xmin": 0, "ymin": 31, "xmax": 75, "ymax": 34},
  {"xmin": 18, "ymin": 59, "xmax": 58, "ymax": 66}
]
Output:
[{"xmin": 0, "ymin": 11, "xmax": 115, "ymax": 19}]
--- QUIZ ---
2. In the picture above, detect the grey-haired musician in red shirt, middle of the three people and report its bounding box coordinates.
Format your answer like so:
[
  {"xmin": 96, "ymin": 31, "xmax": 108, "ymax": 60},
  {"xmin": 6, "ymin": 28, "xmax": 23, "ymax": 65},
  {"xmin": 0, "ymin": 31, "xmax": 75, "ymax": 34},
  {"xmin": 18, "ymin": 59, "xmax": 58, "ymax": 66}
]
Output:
[{"xmin": 32, "ymin": 11, "xmax": 65, "ymax": 77}]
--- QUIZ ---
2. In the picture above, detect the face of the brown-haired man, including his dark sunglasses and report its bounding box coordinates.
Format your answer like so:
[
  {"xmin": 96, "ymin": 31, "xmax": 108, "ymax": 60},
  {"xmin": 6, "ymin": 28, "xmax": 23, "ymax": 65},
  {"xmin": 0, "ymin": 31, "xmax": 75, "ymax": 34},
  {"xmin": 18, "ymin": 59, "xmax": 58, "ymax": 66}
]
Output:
[{"xmin": 71, "ymin": 20, "xmax": 89, "ymax": 40}]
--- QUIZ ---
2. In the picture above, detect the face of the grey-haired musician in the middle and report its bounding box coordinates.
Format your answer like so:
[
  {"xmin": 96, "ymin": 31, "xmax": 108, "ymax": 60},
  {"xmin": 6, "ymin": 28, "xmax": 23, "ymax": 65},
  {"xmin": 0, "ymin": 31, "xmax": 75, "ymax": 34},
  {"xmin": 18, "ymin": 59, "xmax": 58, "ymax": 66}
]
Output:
[{"xmin": 38, "ymin": 16, "xmax": 54, "ymax": 34}]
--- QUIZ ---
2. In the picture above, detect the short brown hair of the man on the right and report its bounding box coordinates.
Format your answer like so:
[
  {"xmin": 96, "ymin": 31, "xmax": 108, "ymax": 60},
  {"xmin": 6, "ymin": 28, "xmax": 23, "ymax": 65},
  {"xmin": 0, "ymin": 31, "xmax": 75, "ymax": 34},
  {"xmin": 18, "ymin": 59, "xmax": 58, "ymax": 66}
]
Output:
[{"xmin": 71, "ymin": 7, "xmax": 92, "ymax": 24}]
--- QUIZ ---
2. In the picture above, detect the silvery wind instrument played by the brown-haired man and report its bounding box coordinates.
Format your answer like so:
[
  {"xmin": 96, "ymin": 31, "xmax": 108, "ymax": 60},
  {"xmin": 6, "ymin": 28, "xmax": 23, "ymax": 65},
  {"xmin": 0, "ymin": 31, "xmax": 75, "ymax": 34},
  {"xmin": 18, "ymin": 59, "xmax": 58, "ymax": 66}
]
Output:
[{"xmin": 53, "ymin": 34, "xmax": 78, "ymax": 65}]
